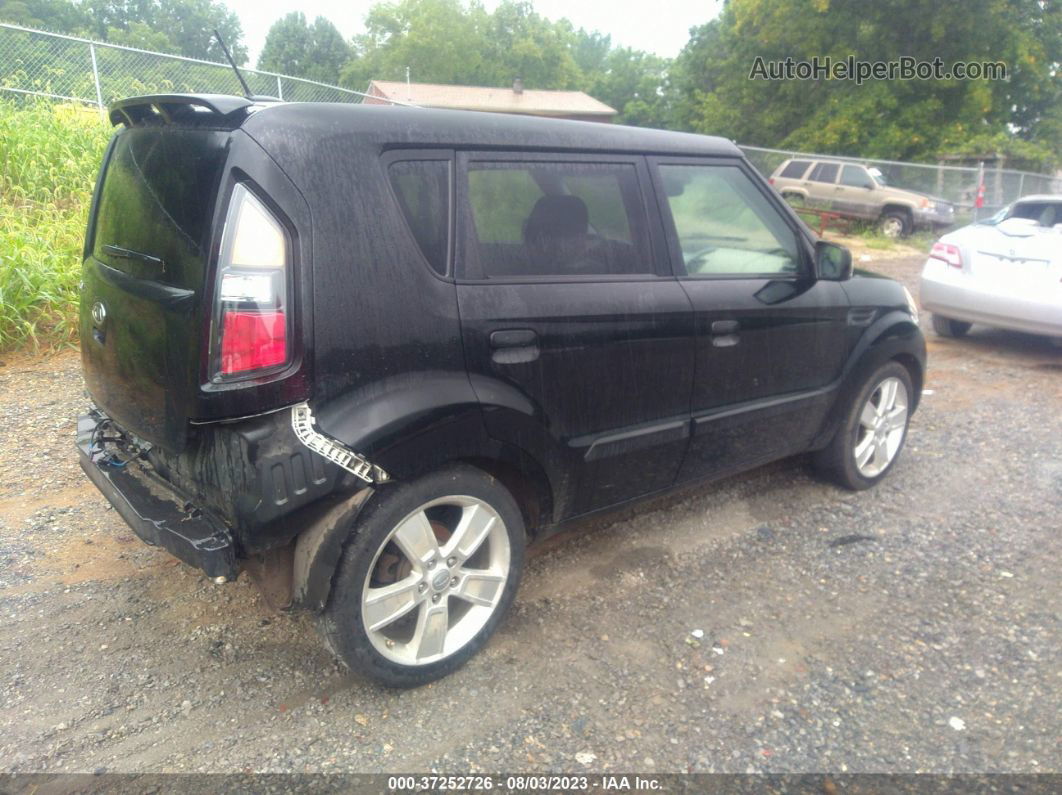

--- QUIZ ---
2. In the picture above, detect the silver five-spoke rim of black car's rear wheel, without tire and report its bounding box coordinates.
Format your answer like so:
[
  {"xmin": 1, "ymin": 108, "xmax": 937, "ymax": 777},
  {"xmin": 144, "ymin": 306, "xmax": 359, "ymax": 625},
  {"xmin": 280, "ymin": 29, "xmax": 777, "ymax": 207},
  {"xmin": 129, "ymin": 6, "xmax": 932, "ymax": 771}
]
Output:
[{"xmin": 361, "ymin": 496, "xmax": 511, "ymax": 666}]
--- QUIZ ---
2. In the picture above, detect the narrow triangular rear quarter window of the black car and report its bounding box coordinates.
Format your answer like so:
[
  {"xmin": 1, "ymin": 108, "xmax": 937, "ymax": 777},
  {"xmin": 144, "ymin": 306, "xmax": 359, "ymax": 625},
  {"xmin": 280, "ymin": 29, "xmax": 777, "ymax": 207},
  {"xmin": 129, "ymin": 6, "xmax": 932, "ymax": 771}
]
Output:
[{"xmin": 388, "ymin": 160, "xmax": 450, "ymax": 275}]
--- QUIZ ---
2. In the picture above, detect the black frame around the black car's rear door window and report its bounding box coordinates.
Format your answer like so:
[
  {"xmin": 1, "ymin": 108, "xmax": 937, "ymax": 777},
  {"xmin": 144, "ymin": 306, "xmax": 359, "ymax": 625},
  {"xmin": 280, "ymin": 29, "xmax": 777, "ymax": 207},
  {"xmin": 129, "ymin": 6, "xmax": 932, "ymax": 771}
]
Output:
[{"xmin": 453, "ymin": 149, "xmax": 673, "ymax": 284}]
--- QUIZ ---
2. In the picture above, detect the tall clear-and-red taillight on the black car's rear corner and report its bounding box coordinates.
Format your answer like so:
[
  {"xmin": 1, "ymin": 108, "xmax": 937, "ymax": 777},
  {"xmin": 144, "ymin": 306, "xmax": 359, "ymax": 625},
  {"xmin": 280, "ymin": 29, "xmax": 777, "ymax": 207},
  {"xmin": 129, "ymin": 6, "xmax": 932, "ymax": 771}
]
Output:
[{"xmin": 212, "ymin": 184, "xmax": 291, "ymax": 378}]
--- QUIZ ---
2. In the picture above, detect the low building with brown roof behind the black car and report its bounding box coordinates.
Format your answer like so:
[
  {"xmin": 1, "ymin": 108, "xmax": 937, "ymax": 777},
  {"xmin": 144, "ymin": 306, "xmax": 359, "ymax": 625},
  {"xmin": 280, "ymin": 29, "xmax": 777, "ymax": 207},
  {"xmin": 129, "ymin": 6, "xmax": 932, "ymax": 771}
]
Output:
[{"xmin": 364, "ymin": 80, "xmax": 616, "ymax": 122}]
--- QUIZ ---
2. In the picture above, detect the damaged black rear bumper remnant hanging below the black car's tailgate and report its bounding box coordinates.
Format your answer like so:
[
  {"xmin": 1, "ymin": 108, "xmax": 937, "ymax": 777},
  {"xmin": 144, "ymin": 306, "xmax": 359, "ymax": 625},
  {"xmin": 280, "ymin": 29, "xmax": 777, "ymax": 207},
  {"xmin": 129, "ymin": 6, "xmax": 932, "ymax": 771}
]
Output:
[{"xmin": 78, "ymin": 412, "xmax": 238, "ymax": 580}]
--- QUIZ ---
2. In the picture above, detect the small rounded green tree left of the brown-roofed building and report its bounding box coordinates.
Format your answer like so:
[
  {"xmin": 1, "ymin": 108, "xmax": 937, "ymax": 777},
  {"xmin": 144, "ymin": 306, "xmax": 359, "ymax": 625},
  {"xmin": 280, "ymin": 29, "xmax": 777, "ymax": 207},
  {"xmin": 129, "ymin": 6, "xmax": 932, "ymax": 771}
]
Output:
[{"xmin": 258, "ymin": 11, "xmax": 350, "ymax": 83}]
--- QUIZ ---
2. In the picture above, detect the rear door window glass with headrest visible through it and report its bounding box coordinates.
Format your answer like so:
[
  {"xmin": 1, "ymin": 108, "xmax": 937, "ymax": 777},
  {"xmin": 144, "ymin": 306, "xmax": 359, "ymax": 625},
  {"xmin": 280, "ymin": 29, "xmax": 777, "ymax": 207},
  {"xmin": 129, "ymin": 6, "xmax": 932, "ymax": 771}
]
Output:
[{"xmin": 462, "ymin": 160, "xmax": 654, "ymax": 279}]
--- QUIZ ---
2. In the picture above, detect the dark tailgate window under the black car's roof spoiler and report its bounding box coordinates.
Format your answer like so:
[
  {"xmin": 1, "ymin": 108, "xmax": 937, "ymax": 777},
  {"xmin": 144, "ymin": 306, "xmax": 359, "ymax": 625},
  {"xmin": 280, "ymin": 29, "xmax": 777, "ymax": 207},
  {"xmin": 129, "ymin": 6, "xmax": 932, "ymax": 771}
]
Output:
[{"xmin": 92, "ymin": 127, "xmax": 227, "ymax": 287}]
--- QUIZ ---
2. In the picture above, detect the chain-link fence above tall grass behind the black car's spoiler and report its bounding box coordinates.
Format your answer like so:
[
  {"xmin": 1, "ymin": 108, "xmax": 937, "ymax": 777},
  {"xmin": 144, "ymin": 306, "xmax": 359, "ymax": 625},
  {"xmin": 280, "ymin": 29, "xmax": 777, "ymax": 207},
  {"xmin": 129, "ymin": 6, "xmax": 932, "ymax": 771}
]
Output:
[{"xmin": 0, "ymin": 22, "xmax": 392, "ymax": 113}]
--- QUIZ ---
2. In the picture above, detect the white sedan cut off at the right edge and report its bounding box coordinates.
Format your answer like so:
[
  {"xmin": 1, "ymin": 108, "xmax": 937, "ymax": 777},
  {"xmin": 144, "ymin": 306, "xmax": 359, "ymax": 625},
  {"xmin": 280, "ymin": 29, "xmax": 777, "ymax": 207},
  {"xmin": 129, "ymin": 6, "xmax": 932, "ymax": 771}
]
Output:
[{"xmin": 921, "ymin": 195, "xmax": 1062, "ymax": 339}]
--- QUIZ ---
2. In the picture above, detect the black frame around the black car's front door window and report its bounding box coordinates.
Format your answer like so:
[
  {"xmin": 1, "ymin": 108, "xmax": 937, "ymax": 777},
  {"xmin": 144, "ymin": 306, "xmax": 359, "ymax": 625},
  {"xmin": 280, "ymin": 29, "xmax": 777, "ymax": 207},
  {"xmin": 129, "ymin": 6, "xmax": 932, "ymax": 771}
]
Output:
[{"xmin": 648, "ymin": 155, "xmax": 815, "ymax": 281}]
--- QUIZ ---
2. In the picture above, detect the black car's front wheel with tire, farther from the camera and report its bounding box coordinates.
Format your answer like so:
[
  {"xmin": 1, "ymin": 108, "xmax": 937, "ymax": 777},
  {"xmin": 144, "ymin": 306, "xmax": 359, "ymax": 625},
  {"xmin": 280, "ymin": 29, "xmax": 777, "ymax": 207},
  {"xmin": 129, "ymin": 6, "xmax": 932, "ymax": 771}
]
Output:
[{"xmin": 815, "ymin": 362, "xmax": 914, "ymax": 491}]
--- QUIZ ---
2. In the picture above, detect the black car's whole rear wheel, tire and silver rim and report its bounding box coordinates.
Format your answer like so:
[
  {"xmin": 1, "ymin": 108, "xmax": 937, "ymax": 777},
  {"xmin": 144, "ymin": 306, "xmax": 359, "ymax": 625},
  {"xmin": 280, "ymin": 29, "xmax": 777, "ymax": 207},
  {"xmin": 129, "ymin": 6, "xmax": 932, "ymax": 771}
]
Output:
[{"xmin": 322, "ymin": 466, "xmax": 525, "ymax": 687}]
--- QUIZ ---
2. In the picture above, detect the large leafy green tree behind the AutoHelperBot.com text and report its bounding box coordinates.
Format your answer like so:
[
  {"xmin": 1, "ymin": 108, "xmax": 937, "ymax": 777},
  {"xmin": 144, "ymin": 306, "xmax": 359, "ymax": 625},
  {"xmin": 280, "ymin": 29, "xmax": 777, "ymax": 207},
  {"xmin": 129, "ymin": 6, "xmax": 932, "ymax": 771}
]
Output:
[{"xmin": 672, "ymin": 0, "xmax": 1062, "ymax": 165}]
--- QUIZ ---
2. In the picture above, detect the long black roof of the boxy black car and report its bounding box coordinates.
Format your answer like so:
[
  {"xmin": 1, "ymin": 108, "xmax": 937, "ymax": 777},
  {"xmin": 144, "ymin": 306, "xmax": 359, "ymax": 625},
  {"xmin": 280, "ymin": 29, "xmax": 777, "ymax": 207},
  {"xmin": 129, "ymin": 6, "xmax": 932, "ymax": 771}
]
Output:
[{"xmin": 242, "ymin": 103, "xmax": 741, "ymax": 156}]
